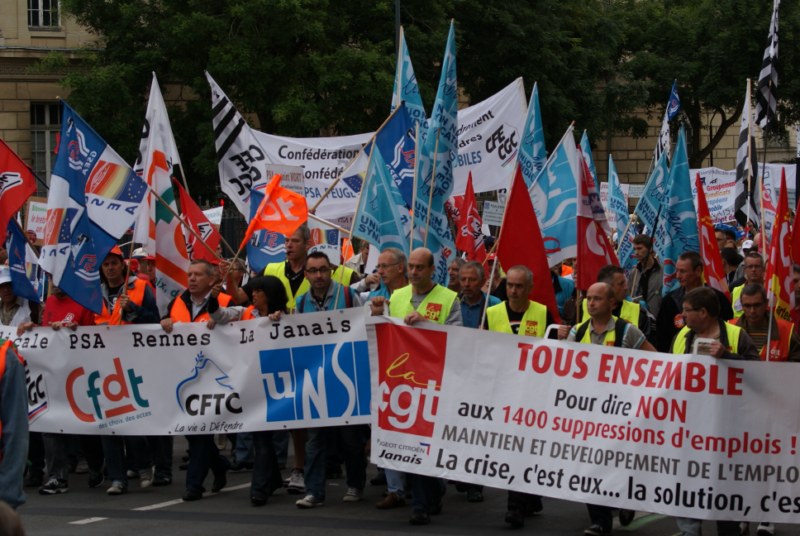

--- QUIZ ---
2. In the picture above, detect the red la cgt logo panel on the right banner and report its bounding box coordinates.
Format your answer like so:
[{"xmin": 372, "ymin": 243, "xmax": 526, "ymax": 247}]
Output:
[{"xmin": 375, "ymin": 324, "xmax": 447, "ymax": 437}]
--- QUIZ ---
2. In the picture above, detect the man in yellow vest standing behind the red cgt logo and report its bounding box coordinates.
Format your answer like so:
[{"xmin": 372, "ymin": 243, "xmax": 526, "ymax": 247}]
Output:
[{"xmin": 370, "ymin": 248, "xmax": 462, "ymax": 525}]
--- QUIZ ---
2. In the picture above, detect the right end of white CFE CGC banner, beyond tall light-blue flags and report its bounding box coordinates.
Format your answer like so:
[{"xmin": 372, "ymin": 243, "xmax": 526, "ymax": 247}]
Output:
[{"xmin": 453, "ymin": 78, "xmax": 528, "ymax": 195}]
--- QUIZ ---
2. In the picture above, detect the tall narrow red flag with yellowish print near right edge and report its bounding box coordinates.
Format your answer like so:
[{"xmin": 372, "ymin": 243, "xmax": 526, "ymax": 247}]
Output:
[{"xmin": 765, "ymin": 170, "xmax": 792, "ymax": 322}]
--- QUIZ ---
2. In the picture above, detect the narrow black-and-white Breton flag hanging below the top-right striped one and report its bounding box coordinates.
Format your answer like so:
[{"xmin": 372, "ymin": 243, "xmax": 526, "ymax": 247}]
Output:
[{"xmin": 734, "ymin": 79, "xmax": 761, "ymax": 227}]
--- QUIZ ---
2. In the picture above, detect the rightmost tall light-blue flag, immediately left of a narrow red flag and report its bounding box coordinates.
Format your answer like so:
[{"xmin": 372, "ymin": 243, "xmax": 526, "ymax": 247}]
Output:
[{"xmin": 653, "ymin": 128, "xmax": 700, "ymax": 294}]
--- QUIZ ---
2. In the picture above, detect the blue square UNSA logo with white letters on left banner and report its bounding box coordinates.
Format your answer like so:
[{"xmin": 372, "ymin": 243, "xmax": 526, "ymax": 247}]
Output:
[{"xmin": 260, "ymin": 341, "xmax": 371, "ymax": 421}]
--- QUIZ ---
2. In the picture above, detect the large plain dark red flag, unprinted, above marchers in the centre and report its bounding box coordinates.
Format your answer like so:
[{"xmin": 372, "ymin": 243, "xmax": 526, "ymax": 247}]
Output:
[{"xmin": 497, "ymin": 165, "xmax": 561, "ymax": 323}]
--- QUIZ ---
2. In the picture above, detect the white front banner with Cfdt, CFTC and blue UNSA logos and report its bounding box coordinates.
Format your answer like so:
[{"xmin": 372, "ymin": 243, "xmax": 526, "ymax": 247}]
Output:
[{"xmin": 18, "ymin": 308, "xmax": 370, "ymax": 435}]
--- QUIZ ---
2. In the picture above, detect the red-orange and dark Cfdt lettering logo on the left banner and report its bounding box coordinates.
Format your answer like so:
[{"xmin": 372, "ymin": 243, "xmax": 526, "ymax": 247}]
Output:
[{"xmin": 67, "ymin": 357, "xmax": 150, "ymax": 422}]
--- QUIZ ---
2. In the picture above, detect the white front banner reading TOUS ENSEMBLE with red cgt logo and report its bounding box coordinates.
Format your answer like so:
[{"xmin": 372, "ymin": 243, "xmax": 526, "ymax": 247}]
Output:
[{"xmin": 368, "ymin": 322, "xmax": 800, "ymax": 523}]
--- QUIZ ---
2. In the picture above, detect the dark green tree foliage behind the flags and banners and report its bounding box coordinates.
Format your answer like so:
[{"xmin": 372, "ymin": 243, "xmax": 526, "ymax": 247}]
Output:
[{"xmin": 53, "ymin": 0, "xmax": 800, "ymax": 195}]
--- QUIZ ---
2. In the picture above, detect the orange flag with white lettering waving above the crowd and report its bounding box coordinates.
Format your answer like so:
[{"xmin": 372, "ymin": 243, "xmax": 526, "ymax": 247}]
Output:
[{"xmin": 239, "ymin": 175, "xmax": 308, "ymax": 249}]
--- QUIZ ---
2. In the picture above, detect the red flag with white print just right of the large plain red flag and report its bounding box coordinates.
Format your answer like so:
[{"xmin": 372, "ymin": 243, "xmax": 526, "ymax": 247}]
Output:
[{"xmin": 575, "ymin": 149, "xmax": 619, "ymax": 290}]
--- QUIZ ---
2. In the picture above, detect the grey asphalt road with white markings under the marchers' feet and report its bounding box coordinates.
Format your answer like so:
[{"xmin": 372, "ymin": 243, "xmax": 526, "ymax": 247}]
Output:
[{"xmin": 15, "ymin": 441, "xmax": 800, "ymax": 536}]
